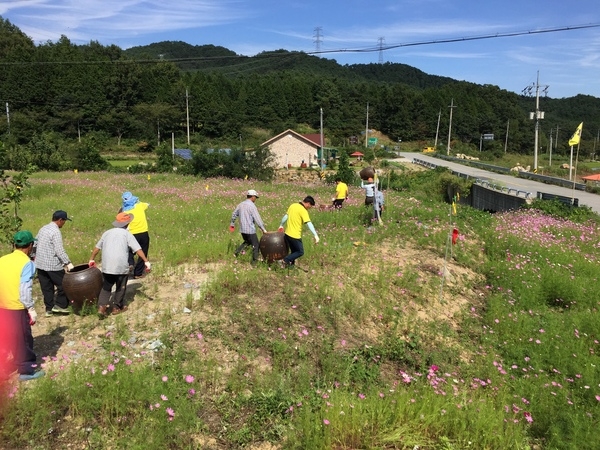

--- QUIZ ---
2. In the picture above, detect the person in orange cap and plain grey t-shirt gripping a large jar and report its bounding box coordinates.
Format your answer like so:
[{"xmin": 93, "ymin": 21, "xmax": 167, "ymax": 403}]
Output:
[{"xmin": 88, "ymin": 213, "xmax": 152, "ymax": 319}]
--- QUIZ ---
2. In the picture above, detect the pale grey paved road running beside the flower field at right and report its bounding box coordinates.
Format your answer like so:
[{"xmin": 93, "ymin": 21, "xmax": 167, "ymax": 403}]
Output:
[{"xmin": 397, "ymin": 152, "xmax": 600, "ymax": 214}]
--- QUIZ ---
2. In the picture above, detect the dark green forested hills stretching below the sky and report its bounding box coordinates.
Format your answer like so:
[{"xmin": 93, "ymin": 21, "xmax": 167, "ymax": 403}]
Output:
[{"xmin": 0, "ymin": 18, "xmax": 600, "ymax": 171}]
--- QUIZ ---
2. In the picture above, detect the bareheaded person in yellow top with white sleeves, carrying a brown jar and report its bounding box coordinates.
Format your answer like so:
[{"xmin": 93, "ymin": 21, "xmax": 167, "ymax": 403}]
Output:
[{"xmin": 278, "ymin": 195, "xmax": 319, "ymax": 267}]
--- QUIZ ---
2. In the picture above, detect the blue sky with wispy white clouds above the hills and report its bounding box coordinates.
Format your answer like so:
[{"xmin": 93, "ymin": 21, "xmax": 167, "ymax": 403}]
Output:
[{"xmin": 0, "ymin": 0, "xmax": 600, "ymax": 98}]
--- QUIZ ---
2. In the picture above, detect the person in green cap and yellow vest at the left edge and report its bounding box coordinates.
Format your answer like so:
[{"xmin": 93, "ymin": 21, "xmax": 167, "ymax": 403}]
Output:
[{"xmin": 0, "ymin": 230, "xmax": 44, "ymax": 381}]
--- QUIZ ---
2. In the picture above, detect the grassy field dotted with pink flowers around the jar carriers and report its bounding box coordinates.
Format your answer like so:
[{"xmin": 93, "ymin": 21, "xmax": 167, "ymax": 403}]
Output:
[{"xmin": 0, "ymin": 167, "xmax": 600, "ymax": 450}]
